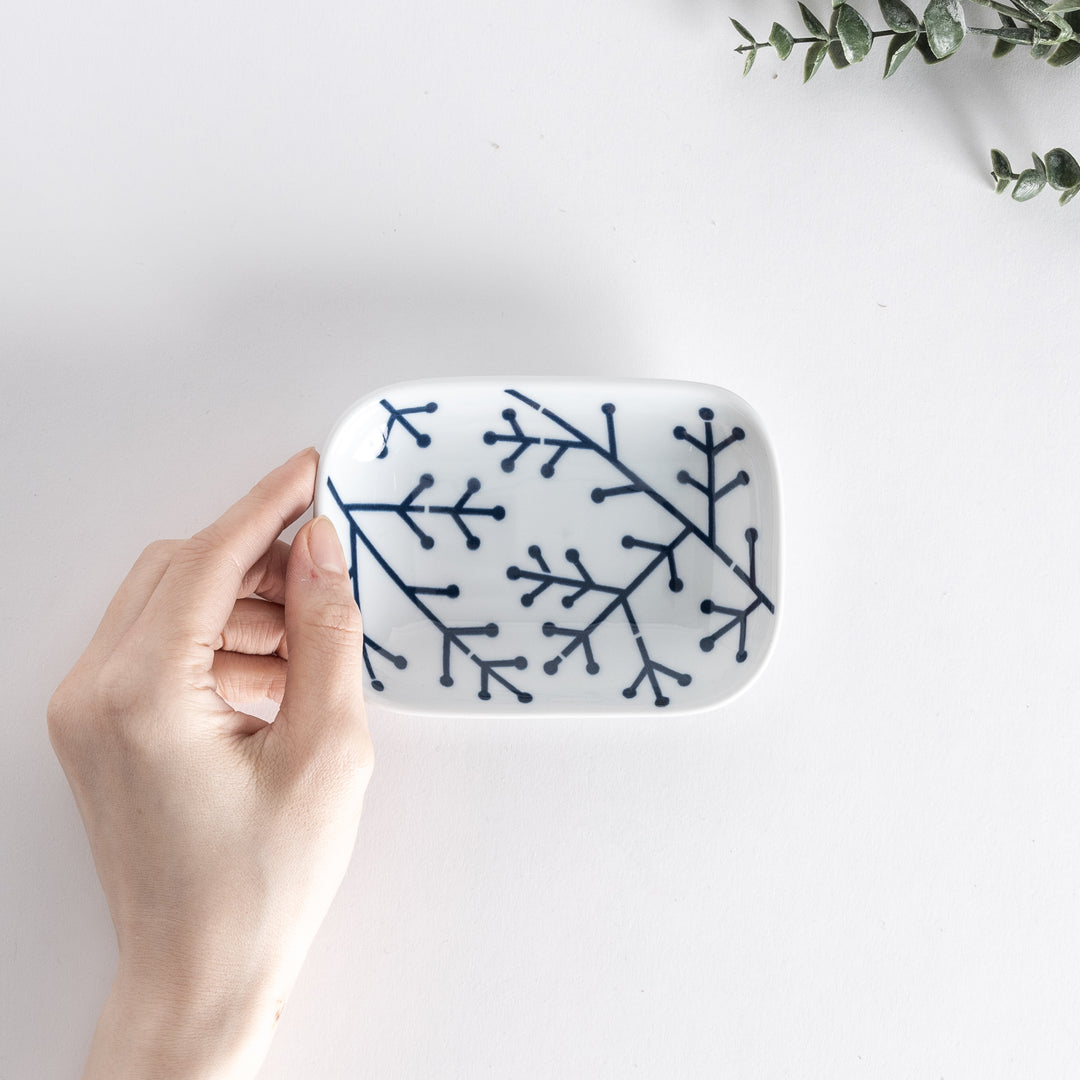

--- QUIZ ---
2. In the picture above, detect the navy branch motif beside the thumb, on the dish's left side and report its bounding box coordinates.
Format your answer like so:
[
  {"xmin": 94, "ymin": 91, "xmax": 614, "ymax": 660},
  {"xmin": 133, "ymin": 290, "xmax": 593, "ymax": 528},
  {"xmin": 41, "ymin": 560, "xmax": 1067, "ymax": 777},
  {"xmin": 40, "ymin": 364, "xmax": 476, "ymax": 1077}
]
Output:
[{"xmin": 326, "ymin": 473, "xmax": 532, "ymax": 705}]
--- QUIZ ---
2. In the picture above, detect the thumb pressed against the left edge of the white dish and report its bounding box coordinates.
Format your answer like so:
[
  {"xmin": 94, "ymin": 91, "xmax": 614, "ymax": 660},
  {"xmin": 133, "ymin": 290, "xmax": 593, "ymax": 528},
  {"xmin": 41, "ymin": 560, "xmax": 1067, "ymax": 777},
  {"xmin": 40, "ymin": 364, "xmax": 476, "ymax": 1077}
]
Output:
[{"xmin": 275, "ymin": 516, "xmax": 370, "ymax": 756}]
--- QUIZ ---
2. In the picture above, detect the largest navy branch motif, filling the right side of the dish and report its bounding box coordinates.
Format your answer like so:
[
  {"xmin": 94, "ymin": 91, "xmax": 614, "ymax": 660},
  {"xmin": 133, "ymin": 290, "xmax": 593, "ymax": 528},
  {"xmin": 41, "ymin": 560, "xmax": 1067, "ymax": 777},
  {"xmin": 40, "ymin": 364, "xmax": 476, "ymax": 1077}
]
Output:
[{"xmin": 484, "ymin": 389, "xmax": 774, "ymax": 707}]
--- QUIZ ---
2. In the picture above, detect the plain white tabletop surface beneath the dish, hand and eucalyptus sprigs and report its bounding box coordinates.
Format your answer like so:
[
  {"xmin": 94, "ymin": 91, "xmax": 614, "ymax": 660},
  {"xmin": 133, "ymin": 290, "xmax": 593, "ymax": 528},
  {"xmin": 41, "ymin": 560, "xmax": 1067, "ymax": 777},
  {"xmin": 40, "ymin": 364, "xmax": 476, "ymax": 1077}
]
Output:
[{"xmin": 0, "ymin": 0, "xmax": 1080, "ymax": 1080}]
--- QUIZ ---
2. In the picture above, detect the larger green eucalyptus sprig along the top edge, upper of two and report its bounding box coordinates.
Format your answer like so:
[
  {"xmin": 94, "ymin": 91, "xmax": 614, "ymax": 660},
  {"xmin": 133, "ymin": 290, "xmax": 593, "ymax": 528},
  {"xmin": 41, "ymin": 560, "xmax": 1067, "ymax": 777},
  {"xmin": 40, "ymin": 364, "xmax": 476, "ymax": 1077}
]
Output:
[{"xmin": 731, "ymin": 0, "xmax": 1080, "ymax": 82}]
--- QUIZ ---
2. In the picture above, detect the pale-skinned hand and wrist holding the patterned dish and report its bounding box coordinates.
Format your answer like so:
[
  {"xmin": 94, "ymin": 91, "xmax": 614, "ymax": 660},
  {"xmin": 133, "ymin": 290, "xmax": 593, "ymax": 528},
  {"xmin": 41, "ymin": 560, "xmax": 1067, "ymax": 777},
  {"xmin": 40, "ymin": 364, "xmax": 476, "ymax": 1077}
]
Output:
[{"xmin": 49, "ymin": 450, "xmax": 373, "ymax": 1080}]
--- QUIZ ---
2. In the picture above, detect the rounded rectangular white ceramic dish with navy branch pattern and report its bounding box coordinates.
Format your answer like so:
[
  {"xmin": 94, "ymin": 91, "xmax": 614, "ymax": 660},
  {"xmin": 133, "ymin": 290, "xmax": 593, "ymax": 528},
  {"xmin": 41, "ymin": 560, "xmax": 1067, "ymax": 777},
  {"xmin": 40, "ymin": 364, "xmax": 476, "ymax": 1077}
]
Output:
[{"xmin": 315, "ymin": 378, "xmax": 780, "ymax": 717}]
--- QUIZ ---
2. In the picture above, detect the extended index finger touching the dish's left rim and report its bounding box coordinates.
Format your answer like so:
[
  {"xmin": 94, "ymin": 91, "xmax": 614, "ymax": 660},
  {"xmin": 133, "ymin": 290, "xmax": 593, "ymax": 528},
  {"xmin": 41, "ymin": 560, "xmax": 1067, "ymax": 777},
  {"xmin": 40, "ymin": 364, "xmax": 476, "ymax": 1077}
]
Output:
[{"xmin": 140, "ymin": 447, "xmax": 319, "ymax": 651}]
